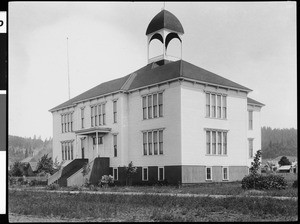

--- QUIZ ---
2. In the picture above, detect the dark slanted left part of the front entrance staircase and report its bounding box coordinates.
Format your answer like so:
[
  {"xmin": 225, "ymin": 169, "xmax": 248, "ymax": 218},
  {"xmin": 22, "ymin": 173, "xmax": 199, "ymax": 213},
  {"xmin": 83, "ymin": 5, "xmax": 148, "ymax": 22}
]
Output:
[{"xmin": 48, "ymin": 159, "xmax": 88, "ymax": 187}]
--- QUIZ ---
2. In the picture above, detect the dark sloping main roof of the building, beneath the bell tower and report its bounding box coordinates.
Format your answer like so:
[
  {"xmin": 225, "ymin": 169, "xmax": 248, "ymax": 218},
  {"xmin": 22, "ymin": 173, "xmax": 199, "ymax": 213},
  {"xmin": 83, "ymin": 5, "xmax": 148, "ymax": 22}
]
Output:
[{"xmin": 50, "ymin": 60, "xmax": 252, "ymax": 111}]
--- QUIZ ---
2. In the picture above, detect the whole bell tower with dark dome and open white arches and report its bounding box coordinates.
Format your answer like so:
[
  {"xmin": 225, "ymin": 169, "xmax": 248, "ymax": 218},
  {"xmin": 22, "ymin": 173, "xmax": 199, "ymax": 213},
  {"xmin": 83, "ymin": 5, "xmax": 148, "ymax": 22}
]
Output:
[{"xmin": 146, "ymin": 9, "xmax": 184, "ymax": 64}]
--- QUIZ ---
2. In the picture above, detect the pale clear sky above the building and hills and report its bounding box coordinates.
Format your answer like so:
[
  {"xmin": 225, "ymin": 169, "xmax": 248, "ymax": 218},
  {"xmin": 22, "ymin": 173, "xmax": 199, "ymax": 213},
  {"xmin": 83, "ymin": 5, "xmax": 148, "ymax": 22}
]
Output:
[{"xmin": 8, "ymin": 1, "xmax": 297, "ymax": 139}]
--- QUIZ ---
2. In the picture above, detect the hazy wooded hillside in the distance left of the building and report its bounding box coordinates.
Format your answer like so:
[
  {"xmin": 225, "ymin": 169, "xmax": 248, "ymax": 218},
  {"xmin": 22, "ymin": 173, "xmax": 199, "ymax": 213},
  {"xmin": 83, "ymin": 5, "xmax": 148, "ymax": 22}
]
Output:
[{"xmin": 8, "ymin": 135, "xmax": 52, "ymax": 164}]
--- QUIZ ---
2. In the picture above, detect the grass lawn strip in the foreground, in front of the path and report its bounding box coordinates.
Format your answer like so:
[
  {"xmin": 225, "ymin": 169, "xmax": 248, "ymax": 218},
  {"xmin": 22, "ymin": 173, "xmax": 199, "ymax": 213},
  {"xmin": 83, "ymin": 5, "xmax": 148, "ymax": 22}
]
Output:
[{"xmin": 8, "ymin": 190, "xmax": 298, "ymax": 222}]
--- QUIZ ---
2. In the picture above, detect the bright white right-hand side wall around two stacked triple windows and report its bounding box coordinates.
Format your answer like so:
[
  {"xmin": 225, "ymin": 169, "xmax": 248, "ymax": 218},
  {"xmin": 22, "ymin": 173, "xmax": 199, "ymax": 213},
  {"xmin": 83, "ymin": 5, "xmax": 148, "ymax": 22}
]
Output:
[{"xmin": 181, "ymin": 82, "xmax": 247, "ymax": 166}]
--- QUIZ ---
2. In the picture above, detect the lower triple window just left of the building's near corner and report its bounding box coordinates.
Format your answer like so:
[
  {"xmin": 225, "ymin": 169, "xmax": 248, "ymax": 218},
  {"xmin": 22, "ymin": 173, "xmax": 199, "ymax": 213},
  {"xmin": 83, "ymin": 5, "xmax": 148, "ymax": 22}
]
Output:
[{"xmin": 143, "ymin": 130, "xmax": 163, "ymax": 155}]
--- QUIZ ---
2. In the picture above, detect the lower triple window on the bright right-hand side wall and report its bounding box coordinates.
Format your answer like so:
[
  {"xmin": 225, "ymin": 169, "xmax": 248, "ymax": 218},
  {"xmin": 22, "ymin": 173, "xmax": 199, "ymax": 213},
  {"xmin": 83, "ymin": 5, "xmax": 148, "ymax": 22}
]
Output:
[{"xmin": 205, "ymin": 130, "xmax": 227, "ymax": 155}]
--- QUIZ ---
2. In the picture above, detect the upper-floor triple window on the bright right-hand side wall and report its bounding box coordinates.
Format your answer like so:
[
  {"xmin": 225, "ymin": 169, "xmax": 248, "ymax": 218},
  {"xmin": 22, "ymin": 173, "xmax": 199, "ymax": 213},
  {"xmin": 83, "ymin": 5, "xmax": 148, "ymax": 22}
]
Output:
[{"xmin": 205, "ymin": 92, "xmax": 227, "ymax": 119}]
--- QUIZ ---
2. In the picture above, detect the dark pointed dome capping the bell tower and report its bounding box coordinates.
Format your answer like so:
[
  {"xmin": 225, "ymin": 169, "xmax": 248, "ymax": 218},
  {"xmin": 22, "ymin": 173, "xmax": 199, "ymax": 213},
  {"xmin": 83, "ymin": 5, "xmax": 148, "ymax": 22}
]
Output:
[{"xmin": 146, "ymin": 10, "xmax": 184, "ymax": 35}]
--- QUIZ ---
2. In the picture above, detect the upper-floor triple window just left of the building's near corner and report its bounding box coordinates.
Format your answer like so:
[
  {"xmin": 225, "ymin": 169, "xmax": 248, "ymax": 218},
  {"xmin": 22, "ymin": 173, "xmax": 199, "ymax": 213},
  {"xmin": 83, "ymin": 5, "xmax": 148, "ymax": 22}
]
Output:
[{"xmin": 142, "ymin": 92, "xmax": 163, "ymax": 120}]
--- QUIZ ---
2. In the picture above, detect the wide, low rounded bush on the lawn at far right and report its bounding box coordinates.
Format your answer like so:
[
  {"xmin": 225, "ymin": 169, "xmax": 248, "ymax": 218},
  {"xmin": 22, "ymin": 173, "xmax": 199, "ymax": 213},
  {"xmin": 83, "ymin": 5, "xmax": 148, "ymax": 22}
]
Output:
[{"xmin": 242, "ymin": 174, "xmax": 287, "ymax": 190}]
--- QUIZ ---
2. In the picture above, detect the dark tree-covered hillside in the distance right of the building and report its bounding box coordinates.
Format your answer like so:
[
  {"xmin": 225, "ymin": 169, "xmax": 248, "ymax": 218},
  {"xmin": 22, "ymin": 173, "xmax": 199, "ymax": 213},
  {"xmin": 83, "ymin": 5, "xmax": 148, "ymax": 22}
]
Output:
[{"xmin": 261, "ymin": 127, "xmax": 298, "ymax": 160}]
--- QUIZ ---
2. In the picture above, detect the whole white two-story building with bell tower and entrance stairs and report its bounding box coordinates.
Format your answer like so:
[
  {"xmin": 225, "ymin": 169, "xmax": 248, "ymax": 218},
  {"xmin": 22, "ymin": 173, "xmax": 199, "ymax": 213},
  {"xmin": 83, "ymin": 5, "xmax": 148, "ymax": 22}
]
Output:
[{"xmin": 48, "ymin": 10, "xmax": 264, "ymax": 186}]
